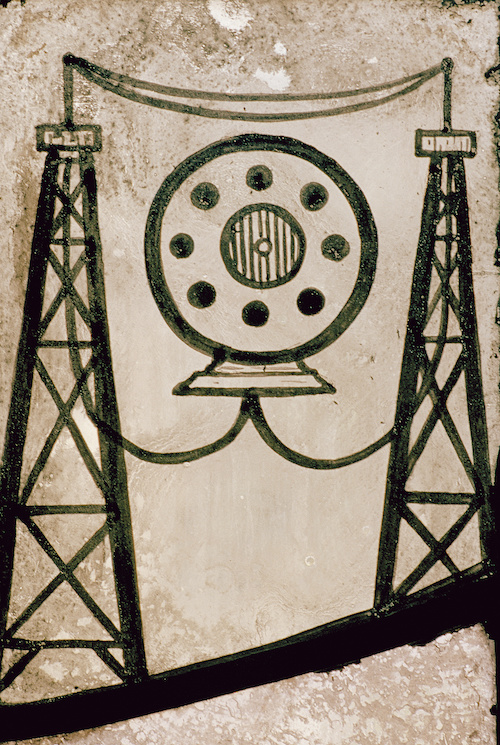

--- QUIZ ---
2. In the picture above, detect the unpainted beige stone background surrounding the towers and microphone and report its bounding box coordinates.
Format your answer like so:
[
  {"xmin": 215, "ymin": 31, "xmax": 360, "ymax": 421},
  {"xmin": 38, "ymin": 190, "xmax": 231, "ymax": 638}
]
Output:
[{"xmin": 0, "ymin": 0, "xmax": 500, "ymax": 745}]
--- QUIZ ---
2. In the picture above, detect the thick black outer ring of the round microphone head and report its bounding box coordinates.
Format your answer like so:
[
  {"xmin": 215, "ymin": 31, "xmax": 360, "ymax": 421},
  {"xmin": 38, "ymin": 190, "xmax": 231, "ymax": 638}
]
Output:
[{"xmin": 144, "ymin": 134, "xmax": 378, "ymax": 365}]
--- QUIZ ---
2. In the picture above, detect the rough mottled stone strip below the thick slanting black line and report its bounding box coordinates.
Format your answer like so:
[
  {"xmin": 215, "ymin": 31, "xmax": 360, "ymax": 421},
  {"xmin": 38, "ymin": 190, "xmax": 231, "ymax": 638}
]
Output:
[{"xmin": 3, "ymin": 627, "xmax": 496, "ymax": 745}]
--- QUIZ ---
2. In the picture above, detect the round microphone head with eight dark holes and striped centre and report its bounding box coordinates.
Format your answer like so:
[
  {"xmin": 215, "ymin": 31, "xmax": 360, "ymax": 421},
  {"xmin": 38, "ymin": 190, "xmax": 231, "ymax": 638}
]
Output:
[{"xmin": 145, "ymin": 134, "xmax": 378, "ymax": 365}]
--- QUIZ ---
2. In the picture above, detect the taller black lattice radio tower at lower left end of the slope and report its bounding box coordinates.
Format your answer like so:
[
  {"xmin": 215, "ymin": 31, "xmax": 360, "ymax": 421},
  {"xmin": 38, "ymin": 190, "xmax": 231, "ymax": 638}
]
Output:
[{"xmin": 0, "ymin": 67, "xmax": 146, "ymax": 700}]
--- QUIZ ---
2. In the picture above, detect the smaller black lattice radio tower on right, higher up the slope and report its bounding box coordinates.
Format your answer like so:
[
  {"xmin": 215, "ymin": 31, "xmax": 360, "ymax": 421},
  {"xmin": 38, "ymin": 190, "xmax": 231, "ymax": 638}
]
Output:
[{"xmin": 375, "ymin": 59, "xmax": 494, "ymax": 610}]
